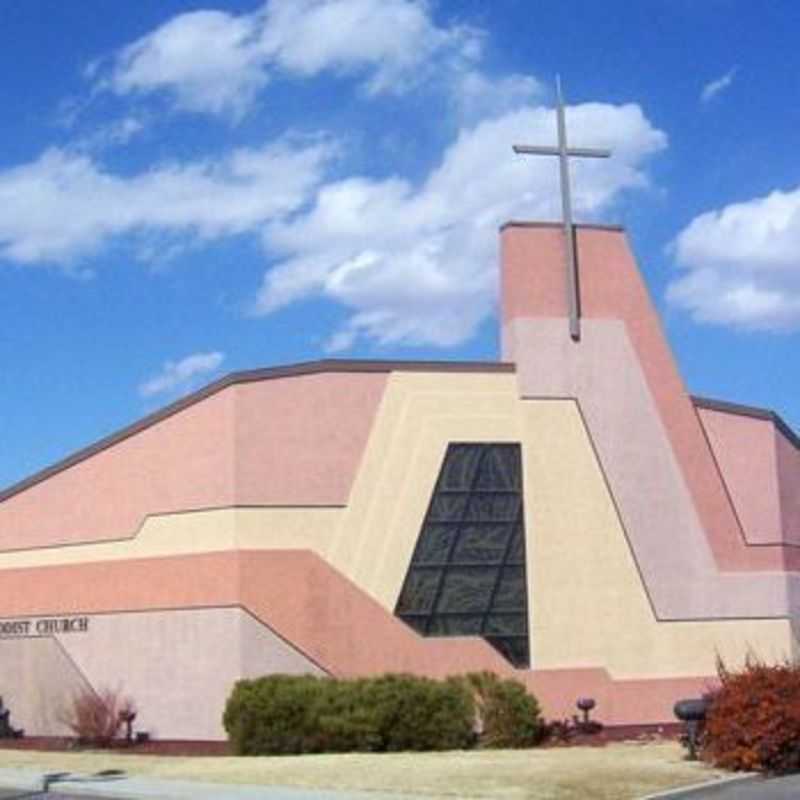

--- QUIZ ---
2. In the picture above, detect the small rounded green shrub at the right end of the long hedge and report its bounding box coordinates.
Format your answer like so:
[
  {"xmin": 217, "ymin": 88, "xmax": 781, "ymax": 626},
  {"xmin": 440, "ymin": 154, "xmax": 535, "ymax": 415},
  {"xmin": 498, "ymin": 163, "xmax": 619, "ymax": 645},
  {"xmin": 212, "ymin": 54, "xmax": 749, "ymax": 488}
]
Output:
[{"xmin": 466, "ymin": 672, "xmax": 546, "ymax": 748}]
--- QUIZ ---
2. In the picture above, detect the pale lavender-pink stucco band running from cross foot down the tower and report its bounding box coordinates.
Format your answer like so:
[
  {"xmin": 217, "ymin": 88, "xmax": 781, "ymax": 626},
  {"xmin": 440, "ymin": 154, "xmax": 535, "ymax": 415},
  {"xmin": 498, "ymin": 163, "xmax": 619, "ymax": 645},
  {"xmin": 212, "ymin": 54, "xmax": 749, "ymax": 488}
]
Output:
[{"xmin": 506, "ymin": 318, "xmax": 800, "ymax": 621}]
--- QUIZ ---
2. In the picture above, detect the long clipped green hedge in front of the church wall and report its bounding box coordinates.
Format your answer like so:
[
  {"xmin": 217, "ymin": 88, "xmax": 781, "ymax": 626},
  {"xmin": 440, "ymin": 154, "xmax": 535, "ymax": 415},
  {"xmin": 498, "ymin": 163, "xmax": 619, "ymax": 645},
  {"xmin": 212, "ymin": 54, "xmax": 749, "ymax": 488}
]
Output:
[{"xmin": 223, "ymin": 675, "xmax": 475, "ymax": 755}]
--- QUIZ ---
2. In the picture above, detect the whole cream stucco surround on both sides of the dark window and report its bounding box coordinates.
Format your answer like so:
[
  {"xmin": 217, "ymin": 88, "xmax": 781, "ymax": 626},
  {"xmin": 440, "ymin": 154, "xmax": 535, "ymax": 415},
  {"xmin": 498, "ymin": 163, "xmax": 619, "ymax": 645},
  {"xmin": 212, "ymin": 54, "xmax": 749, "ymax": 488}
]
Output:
[{"xmin": 310, "ymin": 375, "xmax": 792, "ymax": 678}]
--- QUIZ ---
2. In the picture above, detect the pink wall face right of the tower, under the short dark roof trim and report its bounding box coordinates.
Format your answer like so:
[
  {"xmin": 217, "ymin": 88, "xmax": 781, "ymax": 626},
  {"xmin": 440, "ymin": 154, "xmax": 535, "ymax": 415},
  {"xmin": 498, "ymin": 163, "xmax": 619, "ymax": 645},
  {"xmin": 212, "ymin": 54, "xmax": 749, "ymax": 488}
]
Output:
[{"xmin": 697, "ymin": 408, "xmax": 784, "ymax": 544}]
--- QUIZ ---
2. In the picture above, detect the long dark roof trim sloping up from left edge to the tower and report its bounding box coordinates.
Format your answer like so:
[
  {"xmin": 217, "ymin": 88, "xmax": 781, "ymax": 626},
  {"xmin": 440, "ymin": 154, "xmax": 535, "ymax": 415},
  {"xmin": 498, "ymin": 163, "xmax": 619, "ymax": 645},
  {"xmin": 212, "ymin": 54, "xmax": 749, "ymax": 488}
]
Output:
[{"xmin": 0, "ymin": 359, "xmax": 515, "ymax": 503}]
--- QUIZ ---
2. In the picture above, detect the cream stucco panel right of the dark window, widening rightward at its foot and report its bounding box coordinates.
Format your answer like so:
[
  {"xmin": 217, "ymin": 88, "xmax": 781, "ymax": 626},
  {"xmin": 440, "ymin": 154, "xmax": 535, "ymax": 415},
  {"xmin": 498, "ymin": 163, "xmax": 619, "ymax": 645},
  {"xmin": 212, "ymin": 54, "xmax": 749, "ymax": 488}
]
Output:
[{"xmin": 525, "ymin": 400, "xmax": 793, "ymax": 679}]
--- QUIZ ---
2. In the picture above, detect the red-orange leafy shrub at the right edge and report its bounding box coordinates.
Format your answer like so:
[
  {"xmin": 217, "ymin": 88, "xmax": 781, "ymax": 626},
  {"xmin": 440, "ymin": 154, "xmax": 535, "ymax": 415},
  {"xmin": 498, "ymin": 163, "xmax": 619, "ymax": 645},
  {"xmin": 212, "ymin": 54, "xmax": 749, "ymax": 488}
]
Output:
[{"xmin": 703, "ymin": 657, "xmax": 800, "ymax": 773}]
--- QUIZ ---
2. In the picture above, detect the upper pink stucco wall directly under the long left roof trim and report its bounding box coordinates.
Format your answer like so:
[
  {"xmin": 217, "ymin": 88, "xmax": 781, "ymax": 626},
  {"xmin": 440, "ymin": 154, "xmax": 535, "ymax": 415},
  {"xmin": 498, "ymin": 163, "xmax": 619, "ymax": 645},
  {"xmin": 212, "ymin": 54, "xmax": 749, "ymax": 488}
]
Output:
[{"xmin": 0, "ymin": 372, "xmax": 387, "ymax": 551}]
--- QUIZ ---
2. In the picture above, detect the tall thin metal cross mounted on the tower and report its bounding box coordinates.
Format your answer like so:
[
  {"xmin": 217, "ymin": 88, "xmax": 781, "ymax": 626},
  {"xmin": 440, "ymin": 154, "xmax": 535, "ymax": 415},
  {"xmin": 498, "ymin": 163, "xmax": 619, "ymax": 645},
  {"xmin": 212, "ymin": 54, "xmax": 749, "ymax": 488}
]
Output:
[{"xmin": 513, "ymin": 76, "xmax": 611, "ymax": 342}]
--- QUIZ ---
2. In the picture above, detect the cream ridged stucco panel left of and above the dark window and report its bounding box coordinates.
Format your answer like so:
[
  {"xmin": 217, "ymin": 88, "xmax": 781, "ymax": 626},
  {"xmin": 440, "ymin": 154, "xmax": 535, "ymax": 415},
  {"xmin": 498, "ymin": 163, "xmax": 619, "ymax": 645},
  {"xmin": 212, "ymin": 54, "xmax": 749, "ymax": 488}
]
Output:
[{"xmin": 328, "ymin": 373, "xmax": 520, "ymax": 610}]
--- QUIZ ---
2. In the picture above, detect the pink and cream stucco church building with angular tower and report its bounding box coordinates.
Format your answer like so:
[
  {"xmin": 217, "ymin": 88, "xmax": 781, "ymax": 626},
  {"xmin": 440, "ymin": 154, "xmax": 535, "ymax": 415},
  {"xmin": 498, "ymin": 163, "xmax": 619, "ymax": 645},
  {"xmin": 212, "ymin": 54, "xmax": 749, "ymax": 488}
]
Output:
[{"xmin": 0, "ymin": 217, "xmax": 800, "ymax": 740}]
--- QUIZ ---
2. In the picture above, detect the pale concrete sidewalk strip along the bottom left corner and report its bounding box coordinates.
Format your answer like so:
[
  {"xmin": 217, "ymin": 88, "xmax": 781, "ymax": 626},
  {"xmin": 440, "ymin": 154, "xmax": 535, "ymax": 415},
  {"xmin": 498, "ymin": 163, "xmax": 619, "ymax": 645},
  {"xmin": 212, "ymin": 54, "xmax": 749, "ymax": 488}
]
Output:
[{"xmin": 0, "ymin": 769, "xmax": 430, "ymax": 800}]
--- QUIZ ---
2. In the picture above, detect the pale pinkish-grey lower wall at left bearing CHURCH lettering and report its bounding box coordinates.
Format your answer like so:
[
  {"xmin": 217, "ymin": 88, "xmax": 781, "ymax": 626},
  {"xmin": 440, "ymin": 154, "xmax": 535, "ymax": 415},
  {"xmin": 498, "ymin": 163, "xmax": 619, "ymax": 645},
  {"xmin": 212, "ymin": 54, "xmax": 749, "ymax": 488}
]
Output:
[{"xmin": 0, "ymin": 608, "xmax": 322, "ymax": 740}]
